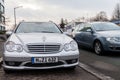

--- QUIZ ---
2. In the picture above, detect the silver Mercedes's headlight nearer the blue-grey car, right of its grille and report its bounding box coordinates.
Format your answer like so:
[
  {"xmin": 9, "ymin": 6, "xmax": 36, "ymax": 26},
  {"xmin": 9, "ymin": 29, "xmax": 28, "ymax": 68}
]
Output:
[{"xmin": 64, "ymin": 41, "xmax": 78, "ymax": 51}]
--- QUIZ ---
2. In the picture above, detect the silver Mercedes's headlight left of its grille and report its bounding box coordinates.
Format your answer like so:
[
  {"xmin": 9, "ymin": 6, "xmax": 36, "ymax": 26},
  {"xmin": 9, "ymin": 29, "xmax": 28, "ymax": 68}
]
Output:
[{"xmin": 5, "ymin": 41, "xmax": 23, "ymax": 52}]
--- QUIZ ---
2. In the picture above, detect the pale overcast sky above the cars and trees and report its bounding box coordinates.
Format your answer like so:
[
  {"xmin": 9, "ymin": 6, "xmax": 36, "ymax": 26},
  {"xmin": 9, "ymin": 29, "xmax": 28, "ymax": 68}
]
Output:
[{"xmin": 5, "ymin": 0, "xmax": 120, "ymax": 27}]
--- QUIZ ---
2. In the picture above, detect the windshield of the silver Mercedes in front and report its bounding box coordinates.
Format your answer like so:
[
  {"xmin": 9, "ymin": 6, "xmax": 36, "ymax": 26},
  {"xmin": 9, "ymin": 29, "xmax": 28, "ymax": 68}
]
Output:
[{"xmin": 16, "ymin": 22, "xmax": 61, "ymax": 33}]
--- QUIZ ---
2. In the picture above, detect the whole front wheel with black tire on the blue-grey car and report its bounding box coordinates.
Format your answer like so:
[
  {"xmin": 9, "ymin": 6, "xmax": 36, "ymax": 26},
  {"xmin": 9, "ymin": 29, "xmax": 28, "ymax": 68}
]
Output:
[{"xmin": 94, "ymin": 41, "xmax": 104, "ymax": 55}]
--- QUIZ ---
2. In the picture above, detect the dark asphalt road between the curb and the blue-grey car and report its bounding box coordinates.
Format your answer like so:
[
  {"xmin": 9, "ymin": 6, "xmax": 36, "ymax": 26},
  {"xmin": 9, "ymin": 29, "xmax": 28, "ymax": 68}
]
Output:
[{"xmin": 80, "ymin": 48, "xmax": 120, "ymax": 80}]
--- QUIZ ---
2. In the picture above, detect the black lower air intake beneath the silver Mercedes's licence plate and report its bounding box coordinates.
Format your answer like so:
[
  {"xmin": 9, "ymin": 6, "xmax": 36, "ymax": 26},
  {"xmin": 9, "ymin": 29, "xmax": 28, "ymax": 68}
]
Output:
[{"xmin": 24, "ymin": 62, "xmax": 64, "ymax": 67}]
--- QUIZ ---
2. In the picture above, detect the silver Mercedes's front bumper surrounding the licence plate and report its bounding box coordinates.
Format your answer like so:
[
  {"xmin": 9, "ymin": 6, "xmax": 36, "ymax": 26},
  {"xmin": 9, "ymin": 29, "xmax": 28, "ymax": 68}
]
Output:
[{"xmin": 3, "ymin": 54, "xmax": 79, "ymax": 70}]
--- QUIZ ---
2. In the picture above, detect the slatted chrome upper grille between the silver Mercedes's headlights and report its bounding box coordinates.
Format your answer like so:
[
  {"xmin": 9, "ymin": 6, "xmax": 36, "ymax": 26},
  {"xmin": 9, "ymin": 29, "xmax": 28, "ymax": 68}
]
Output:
[{"xmin": 27, "ymin": 44, "xmax": 60, "ymax": 53}]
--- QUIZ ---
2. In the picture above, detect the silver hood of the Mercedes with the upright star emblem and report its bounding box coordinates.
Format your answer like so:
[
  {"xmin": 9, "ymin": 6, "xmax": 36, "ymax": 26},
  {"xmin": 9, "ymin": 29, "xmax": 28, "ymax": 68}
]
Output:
[{"xmin": 11, "ymin": 33, "xmax": 73, "ymax": 44}]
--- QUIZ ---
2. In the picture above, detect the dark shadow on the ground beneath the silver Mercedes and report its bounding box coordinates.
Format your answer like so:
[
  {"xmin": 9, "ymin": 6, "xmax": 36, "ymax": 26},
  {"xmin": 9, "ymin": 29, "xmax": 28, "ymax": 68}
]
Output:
[{"xmin": 5, "ymin": 68, "xmax": 75, "ymax": 75}]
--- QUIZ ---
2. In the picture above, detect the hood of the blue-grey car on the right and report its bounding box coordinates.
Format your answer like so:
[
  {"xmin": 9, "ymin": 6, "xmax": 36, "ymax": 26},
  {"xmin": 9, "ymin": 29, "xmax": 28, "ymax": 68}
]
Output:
[{"xmin": 97, "ymin": 30, "xmax": 120, "ymax": 37}]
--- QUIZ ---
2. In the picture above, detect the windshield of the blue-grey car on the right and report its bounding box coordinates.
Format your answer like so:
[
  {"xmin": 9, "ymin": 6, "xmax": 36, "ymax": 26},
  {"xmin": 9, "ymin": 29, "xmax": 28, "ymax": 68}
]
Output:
[{"xmin": 93, "ymin": 23, "xmax": 120, "ymax": 31}]
